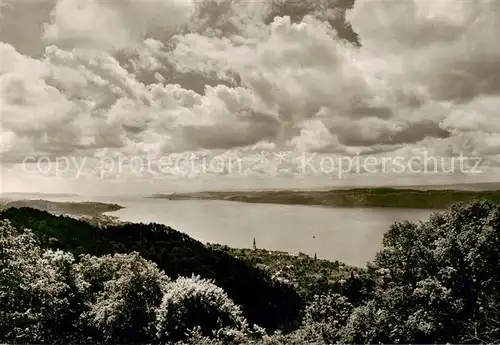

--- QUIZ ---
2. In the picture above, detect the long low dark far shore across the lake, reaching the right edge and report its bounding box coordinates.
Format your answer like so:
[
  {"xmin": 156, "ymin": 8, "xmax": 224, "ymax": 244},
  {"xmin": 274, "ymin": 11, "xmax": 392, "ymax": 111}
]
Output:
[{"xmin": 148, "ymin": 188, "xmax": 500, "ymax": 210}]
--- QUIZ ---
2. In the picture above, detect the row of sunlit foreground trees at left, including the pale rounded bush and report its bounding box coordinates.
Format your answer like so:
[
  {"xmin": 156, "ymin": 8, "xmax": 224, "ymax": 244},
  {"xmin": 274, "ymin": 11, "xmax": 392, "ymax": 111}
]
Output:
[{"xmin": 0, "ymin": 221, "xmax": 247, "ymax": 343}]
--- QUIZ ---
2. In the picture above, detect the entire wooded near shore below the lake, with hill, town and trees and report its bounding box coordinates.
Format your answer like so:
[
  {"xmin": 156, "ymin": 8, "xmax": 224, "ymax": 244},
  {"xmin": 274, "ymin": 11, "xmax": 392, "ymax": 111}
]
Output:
[{"xmin": 0, "ymin": 200, "xmax": 500, "ymax": 345}]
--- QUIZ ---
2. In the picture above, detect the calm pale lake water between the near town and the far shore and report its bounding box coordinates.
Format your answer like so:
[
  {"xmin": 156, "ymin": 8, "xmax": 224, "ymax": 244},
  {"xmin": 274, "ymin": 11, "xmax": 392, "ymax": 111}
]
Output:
[{"xmin": 54, "ymin": 197, "xmax": 432, "ymax": 266}]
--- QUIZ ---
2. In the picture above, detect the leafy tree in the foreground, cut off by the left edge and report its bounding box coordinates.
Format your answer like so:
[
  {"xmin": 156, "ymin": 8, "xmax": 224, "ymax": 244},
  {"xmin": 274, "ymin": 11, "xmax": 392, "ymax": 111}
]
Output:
[{"xmin": 0, "ymin": 221, "xmax": 80, "ymax": 343}]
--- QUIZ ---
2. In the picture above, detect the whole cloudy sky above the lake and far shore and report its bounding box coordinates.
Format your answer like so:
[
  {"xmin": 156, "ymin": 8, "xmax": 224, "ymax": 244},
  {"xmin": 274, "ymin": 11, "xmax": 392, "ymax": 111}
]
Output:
[{"xmin": 0, "ymin": 0, "xmax": 500, "ymax": 194}]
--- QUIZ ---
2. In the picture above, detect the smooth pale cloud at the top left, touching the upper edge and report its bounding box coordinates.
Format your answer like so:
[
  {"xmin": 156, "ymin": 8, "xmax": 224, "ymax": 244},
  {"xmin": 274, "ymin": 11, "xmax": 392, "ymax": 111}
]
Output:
[{"xmin": 43, "ymin": 0, "xmax": 194, "ymax": 50}]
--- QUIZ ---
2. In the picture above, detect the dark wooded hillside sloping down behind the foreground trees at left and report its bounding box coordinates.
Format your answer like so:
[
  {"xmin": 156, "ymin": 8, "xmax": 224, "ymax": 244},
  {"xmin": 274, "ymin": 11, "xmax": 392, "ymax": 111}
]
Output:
[{"xmin": 0, "ymin": 207, "xmax": 303, "ymax": 330}]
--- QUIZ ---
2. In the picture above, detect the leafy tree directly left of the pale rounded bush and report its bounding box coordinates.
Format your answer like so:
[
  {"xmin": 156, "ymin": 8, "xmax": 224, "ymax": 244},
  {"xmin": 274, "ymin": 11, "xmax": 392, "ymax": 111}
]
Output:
[{"xmin": 77, "ymin": 253, "xmax": 170, "ymax": 343}]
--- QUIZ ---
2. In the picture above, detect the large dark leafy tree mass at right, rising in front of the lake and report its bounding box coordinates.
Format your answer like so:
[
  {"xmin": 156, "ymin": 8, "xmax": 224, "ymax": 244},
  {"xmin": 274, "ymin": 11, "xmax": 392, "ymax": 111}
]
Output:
[{"xmin": 343, "ymin": 201, "xmax": 500, "ymax": 343}]
